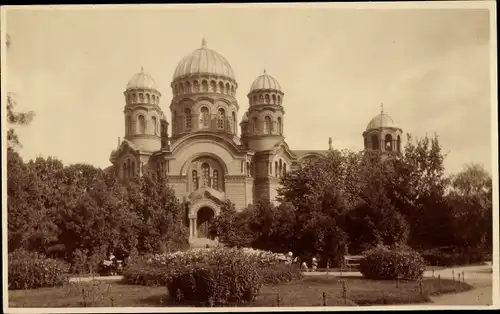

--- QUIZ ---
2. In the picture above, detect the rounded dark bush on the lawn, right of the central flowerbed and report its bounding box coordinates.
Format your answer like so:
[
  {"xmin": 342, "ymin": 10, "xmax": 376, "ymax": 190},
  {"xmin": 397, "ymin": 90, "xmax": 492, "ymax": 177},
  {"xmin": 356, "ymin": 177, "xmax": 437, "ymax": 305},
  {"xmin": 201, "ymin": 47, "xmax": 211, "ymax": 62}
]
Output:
[{"xmin": 359, "ymin": 246, "xmax": 425, "ymax": 280}]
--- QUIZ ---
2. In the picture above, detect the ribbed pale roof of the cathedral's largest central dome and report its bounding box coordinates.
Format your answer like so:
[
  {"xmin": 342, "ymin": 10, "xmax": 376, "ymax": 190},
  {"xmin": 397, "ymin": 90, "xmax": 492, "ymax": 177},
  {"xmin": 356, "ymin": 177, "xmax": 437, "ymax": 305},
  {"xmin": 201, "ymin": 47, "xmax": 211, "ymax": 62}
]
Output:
[{"xmin": 173, "ymin": 39, "xmax": 235, "ymax": 81}]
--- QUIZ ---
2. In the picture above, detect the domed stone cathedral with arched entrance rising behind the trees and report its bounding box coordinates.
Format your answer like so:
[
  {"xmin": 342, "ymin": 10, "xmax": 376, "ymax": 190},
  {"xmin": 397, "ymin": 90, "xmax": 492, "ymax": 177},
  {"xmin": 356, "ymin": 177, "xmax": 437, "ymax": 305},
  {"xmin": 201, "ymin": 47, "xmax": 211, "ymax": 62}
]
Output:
[{"xmin": 106, "ymin": 40, "xmax": 402, "ymax": 243}]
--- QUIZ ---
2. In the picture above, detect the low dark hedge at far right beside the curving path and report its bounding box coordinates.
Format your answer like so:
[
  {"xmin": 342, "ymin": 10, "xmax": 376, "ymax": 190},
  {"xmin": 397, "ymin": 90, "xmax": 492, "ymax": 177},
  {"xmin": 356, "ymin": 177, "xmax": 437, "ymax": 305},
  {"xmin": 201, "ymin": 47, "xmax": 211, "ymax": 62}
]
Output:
[{"xmin": 422, "ymin": 247, "xmax": 487, "ymax": 266}]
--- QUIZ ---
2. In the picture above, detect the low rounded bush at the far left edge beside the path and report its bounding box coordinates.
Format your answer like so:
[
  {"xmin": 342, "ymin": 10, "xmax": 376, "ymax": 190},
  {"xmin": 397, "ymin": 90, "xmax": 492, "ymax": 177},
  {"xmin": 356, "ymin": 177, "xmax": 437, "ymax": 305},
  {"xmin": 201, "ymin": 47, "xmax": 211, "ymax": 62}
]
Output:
[{"xmin": 8, "ymin": 250, "xmax": 69, "ymax": 289}]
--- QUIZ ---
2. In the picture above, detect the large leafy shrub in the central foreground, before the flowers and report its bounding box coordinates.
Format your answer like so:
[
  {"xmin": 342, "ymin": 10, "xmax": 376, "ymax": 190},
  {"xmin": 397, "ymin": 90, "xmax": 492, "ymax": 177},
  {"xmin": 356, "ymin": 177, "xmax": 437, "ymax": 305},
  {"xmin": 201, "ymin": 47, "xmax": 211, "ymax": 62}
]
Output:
[{"xmin": 167, "ymin": 249, "xmax": 262, "ymax": 306}]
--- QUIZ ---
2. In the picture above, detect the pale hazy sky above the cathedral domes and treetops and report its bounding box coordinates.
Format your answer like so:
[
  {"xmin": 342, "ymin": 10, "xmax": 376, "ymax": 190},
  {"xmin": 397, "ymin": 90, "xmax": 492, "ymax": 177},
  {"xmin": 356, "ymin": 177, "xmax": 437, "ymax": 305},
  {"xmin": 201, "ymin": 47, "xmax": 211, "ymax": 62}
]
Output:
[{"xmin": 6, "ymin": 6, "xmax": 494, "ymax": 172}]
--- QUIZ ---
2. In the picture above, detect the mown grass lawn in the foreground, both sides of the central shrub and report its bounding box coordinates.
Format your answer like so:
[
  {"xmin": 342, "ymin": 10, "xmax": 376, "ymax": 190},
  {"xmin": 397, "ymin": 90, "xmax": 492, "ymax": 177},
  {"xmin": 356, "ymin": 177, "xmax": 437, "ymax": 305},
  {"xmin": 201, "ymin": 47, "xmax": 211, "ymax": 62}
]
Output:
[{"xmin": 9, "ymin": 276, "xmax": 472, "ymax": 307}]
